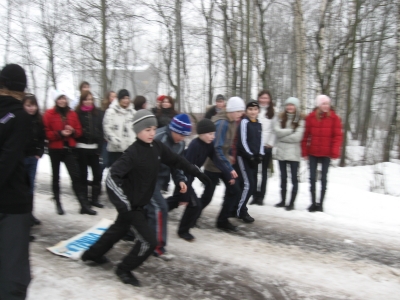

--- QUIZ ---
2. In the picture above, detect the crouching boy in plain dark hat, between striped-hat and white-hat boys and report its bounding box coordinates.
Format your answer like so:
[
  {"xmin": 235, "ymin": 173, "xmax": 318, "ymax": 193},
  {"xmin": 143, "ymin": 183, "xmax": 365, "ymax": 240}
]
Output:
[{"xmin": 167, "ymin": 119, "xmax": 231, "ymax": 242}]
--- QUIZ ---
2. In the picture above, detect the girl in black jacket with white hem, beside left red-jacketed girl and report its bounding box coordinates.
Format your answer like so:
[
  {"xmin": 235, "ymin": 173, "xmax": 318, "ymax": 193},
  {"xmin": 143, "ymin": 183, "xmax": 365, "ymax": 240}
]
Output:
[{"xmin": 75, "ymin": 91, "xmax": 104, "ymax": 208}]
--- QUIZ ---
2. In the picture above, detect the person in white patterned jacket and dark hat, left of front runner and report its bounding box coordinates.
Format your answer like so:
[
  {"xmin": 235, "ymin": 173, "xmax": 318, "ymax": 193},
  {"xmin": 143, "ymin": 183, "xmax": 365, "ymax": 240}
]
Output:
[{"xmin": 103, "ymin": 89, "xmax": 136, "ymax": 167}]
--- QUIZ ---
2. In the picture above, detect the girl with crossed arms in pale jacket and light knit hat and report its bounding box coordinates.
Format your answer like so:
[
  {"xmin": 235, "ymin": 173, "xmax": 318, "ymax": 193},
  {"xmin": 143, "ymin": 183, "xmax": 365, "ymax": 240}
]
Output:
[{"xmin": 275, "ymin": 97, "xmax": 304, "ymax": 210}]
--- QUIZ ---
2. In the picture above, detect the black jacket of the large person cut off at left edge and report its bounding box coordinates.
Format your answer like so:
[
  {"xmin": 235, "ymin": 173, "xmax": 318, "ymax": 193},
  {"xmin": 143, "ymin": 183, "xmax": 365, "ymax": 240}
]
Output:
[{"xmin": 0, "ymin": 96, "xmax": 32, "ymax": 214}]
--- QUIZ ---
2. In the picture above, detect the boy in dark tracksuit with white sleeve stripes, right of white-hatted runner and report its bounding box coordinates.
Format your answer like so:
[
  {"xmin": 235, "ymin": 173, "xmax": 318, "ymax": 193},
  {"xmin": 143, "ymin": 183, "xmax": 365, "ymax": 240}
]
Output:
[{"xmin": 235, "ymin": 101, "xmax": 264, "ymax": 223}]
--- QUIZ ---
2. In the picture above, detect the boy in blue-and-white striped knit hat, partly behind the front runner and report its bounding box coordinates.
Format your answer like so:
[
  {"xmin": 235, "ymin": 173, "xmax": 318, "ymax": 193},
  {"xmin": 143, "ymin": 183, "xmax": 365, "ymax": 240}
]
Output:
[{"xmin": 146, "ymin": 114, "xmax": 192, "ymax": 260}]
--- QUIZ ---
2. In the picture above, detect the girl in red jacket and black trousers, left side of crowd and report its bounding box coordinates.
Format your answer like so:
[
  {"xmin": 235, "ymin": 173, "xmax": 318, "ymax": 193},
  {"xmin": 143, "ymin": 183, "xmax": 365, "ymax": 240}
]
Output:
[{"xmin": 43, "ymin": 94, "xmax": 96, "ymax": 215}]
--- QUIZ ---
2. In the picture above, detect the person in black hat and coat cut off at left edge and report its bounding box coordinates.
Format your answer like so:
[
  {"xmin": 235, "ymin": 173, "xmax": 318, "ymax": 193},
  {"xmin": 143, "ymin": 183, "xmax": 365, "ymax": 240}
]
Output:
[{"xmin": 0, "ymin": 64, "xmax": 32, "ymax": 299}]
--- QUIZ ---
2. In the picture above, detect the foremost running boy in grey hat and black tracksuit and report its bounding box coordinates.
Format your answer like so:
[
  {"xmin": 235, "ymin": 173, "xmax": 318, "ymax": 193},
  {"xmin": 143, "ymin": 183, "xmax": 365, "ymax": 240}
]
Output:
[{"xmin": 82, "ymin": 109, "xmax": 209, "ymax": 286}]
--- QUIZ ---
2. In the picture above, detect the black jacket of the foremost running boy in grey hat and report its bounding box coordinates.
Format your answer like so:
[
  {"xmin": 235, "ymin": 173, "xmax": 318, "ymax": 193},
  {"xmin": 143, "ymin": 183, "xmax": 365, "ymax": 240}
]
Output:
[{"xmin": 106, "ymin": 139, "xmax": 201, "ymax": 213}]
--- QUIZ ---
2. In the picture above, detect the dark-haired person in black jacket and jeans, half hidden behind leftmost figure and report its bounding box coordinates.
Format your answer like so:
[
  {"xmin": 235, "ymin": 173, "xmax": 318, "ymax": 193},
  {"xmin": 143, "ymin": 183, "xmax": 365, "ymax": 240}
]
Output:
[{"xmin": 22, "ymin": 94, "xmax": 46, "ymax": 225}]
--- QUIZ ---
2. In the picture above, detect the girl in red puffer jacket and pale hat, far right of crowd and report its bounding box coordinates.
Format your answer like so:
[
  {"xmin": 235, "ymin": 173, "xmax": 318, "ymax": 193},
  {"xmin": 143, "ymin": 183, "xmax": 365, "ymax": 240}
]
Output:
[{"xmin": 301, "ymin": 95, "xmax": 342, "ymax": 212}]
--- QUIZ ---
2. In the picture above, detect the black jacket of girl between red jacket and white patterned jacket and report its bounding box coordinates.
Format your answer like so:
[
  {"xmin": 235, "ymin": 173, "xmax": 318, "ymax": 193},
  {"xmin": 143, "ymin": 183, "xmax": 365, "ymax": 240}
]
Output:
[{"xmin": 76, "ymin": 108, "xmax": 104, "ymax": 153}]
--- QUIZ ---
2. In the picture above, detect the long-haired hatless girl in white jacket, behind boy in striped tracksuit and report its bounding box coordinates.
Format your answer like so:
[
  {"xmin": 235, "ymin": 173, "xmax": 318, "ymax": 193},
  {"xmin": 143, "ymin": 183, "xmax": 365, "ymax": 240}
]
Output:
[{"xmin": 250, "ymin": 90, "xmax": 276, "ymax": 205}]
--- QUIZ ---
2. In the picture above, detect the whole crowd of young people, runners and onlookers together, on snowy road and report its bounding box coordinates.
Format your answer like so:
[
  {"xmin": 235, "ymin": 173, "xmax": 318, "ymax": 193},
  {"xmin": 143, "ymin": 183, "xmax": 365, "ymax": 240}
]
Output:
[{"xmin": 0, "ymin": 64, "xmax": 342, "ymax": 299}]
